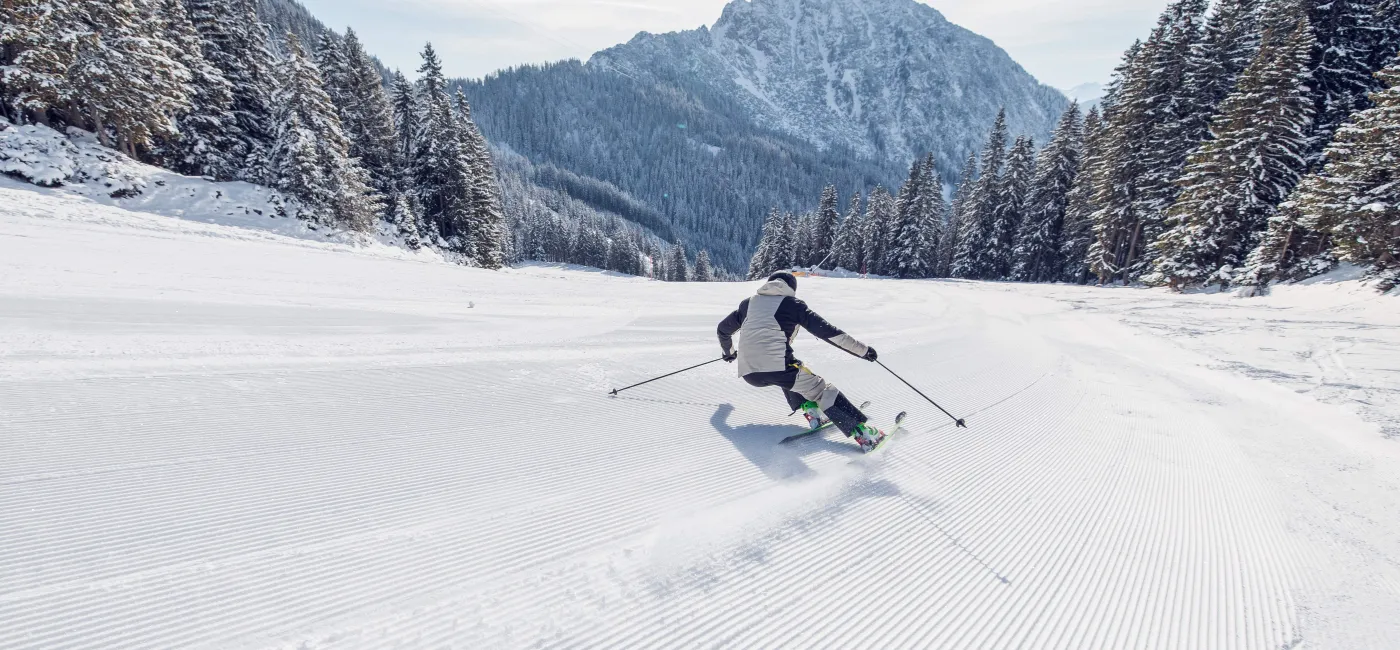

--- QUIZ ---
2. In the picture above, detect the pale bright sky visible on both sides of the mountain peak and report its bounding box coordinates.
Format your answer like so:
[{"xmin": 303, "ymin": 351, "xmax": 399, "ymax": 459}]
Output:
[{"xmin": 302, "ymin": 0, "xmax": 1166, "ymax": 88}]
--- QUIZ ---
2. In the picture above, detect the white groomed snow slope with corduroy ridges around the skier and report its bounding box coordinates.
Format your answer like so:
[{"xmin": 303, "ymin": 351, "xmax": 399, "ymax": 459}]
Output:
[{"xmin": 8, "ymin": 186, "xmax": 1400, "ymax": 649}]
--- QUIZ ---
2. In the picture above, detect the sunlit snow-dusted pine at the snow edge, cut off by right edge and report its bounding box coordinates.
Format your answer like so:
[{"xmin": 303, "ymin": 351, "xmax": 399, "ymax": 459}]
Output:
[{"xmin": 1243, "ymin": 53, "xmax": 1400, "ymax": 291}]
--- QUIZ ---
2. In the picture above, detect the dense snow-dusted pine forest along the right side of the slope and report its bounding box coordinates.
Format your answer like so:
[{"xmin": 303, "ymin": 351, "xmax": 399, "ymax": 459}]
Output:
[{"xmin": 750, "ymin": 0, "xmax": 1400, "ymax": 294}]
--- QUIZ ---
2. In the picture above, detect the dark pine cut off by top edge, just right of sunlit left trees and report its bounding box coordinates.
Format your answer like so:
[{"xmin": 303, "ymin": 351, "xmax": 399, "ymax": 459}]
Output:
[{"xmin": 185, "ymin": 0, "xmax": 277, "ymax": 184}]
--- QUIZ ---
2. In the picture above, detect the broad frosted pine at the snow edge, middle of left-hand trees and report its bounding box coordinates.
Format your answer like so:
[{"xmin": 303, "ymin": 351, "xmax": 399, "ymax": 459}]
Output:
[{"xmin": 270, "ymin": 32, "xmax": 379, "ymax": 233}]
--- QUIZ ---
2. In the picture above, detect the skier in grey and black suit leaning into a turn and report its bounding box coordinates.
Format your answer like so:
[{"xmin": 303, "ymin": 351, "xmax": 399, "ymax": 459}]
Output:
[{"xmin": 718, "ymin": 272, "xmax": 885, "ymax": 451}]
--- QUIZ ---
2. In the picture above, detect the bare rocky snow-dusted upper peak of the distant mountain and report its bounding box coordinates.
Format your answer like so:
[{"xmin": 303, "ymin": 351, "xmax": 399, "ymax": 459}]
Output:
[{"xmin": 591, "ymin": 0, "xmax": 1065, "ymax": 170}]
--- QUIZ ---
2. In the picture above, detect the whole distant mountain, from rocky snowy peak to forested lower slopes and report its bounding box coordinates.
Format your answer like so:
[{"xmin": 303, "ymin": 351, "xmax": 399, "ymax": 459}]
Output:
[{"xmin": 463, "ymin": 0, "xmax": 1067, "ymax": 270}]
